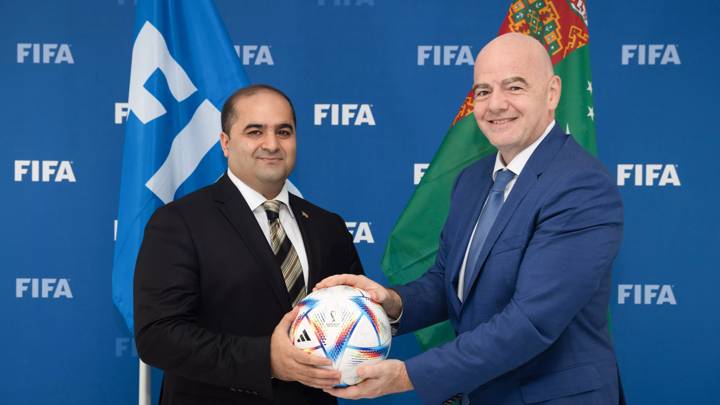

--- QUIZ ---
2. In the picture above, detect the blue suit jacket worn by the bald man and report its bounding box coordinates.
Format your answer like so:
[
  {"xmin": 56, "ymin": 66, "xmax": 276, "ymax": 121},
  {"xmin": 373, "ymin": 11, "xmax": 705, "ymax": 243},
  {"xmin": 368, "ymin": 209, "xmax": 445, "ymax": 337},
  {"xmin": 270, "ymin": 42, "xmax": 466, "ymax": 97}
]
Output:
[{"xmin": 396, "ymin": 125, "xmax": 623, "ymax": 405}]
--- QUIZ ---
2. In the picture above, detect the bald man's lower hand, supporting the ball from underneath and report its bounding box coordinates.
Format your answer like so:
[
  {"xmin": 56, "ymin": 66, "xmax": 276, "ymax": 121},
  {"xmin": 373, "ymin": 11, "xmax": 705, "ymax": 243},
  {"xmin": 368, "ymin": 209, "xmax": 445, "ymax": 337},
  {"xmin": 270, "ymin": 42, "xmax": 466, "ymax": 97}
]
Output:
[{"xmin": 323, "ymin": 360, "xmax": 413, "ymax": 399}]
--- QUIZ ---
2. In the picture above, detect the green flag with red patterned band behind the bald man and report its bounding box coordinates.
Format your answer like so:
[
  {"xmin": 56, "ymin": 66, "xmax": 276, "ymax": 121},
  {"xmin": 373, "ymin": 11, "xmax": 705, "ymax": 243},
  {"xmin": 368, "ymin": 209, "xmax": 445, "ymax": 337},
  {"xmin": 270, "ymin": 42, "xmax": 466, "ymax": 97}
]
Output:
[{"xmin": 382, "ymin": 0, "xmax": 596, "ymax": 349}]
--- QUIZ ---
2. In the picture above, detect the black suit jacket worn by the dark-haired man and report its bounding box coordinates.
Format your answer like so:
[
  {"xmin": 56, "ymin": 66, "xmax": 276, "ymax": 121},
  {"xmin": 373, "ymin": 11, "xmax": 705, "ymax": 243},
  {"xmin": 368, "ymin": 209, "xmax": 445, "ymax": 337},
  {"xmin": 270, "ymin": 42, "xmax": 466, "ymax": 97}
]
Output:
[{"xmin": 134, "ymin": 175, "xmax": 362, "ymax": 405}]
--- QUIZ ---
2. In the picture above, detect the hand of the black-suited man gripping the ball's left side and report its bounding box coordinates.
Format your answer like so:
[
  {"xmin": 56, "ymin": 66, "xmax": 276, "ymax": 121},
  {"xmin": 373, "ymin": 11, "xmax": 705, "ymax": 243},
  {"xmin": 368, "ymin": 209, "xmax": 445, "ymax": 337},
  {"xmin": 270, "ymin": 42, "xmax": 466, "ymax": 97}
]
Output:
[{"xmin": 270, "ymin": 307, "xmax": 340, "ymax": 388}]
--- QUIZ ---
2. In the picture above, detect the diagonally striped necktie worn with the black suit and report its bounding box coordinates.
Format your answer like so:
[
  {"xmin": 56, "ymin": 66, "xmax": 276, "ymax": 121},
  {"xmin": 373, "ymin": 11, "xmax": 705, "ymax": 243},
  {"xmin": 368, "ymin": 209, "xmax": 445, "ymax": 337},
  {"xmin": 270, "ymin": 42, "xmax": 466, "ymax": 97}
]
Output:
[{"xmin": 263, "ymin": 200, "xmax": 307, "ymax": 306}]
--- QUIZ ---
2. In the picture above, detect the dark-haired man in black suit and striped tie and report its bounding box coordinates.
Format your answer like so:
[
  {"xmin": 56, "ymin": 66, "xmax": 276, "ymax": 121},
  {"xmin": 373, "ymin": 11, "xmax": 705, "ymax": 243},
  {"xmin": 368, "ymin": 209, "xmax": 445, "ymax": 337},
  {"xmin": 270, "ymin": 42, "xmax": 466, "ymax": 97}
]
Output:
[{"xmin": 135, "ymin": 85, "xmax": 362, "ymax": 405}]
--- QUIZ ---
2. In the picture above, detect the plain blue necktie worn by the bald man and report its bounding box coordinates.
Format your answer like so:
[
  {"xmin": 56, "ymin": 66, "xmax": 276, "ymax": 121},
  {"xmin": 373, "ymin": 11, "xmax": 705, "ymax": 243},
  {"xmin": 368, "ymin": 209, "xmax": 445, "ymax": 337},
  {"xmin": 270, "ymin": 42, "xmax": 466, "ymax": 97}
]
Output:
[{"xmin": 462, "ymin": 170, "xmax": 515, "ymax": 300}]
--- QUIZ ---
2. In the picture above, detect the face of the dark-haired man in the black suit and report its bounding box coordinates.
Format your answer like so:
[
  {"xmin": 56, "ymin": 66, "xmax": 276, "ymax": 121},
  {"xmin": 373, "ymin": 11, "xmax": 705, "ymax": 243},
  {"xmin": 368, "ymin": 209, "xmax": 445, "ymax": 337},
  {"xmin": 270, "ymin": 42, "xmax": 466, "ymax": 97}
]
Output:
[{"xmin": 220, "ymin": 91, "xmax": 296, "ymax": 199}]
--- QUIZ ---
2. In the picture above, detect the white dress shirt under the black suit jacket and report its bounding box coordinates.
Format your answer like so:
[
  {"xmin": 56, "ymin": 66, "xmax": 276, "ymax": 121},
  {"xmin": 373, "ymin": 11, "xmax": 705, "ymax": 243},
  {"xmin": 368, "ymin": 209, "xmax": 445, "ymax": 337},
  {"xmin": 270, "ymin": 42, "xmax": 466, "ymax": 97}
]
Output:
[{"xmin": 227, "ymin": 168, "xmax": 309, "ymax": 286}]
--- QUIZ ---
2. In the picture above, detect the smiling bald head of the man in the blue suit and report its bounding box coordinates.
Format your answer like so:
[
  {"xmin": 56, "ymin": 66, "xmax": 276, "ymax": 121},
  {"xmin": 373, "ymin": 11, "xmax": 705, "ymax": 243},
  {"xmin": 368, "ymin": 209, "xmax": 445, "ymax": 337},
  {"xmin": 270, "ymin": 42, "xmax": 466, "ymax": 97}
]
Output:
[{"xmin": 473, "ymin": 33, "xmax": 561, "ymax": 164}]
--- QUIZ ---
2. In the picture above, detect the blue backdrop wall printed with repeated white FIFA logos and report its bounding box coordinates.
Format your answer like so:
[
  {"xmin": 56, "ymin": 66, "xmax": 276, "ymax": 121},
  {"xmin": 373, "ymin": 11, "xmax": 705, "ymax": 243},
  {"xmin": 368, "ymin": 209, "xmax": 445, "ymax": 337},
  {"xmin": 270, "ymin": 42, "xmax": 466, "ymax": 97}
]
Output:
[{"xmin": 0, "ymin": 0, "xmax": 720, "ymax": 405}]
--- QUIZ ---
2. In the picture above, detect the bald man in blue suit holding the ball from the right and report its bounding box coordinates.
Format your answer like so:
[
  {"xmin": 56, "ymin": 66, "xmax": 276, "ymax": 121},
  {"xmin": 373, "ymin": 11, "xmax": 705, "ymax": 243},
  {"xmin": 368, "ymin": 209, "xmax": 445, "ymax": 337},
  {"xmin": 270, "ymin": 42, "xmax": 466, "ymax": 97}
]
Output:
[{"xmin": 317, "ymin": 33, "xmax": 623, "ymax": 405}]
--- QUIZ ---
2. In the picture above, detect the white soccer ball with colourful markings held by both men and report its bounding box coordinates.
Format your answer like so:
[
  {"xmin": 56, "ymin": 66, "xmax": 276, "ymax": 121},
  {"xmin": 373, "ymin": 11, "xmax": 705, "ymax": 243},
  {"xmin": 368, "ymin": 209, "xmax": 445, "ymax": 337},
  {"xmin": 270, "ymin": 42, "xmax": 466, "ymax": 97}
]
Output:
[{"xmin": 290, "ymin": 285, "xmax": 392, "ymax": 387}]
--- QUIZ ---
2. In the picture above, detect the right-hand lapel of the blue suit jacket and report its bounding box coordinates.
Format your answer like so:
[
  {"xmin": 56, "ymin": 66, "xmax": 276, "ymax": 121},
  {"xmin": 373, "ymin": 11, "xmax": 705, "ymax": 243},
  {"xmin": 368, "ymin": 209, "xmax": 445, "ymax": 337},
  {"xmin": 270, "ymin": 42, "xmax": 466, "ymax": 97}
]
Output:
[{"xmin": 465, "ymin": 124, "xmax": 568, "ymax": 308}]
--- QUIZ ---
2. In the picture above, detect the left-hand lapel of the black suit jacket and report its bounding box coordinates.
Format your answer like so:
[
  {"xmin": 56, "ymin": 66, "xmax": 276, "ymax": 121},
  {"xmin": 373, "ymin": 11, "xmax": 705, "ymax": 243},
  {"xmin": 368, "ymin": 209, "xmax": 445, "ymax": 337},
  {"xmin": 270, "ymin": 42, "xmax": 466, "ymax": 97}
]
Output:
[{"xmin": 213, "ymin": 174, "xmax": 290, "ymax": 308}]
